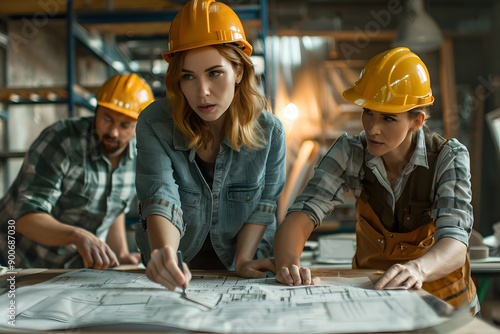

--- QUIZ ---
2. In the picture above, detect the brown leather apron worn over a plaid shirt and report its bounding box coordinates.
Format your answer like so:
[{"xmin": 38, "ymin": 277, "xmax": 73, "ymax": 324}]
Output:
[{"xmin": 352, "ymin": 132, "xmax": 476, "ymax": 307}]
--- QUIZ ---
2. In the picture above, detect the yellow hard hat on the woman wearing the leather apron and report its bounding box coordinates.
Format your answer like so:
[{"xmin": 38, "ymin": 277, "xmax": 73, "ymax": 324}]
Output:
[{"xmin": 342, "ymin": 47, "xmax": 434, "ymax": 113}]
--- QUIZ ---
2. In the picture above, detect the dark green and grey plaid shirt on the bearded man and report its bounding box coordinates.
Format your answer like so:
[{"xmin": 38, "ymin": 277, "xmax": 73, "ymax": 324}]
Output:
[{"xmin": 0, "ymin": 117, "xmax": 136, "ymax": 268}]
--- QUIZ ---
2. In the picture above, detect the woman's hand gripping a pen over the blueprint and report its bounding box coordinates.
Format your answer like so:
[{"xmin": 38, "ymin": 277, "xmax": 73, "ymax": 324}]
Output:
[{"xmin": 146, "ymin": 246, "xmax": 192, "ymax": 291}]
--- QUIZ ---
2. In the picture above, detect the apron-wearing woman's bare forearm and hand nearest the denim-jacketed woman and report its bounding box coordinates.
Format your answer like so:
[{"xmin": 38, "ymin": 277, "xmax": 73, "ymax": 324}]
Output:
[{"xmin": 274, "ymin": 212, "xmax": 319, "ymax": 285}]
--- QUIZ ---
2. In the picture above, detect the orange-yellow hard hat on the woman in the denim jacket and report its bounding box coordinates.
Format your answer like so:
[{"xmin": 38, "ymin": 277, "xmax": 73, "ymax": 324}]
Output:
[{"xmin": 161, "ymin": 0, "xmax": 252, "ymax": 62}]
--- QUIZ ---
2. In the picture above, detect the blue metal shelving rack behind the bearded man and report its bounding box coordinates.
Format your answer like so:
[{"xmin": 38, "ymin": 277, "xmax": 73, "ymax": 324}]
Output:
[{"xmin": 0, "ymin": 0, "xmax": 268, "ymax": 189}]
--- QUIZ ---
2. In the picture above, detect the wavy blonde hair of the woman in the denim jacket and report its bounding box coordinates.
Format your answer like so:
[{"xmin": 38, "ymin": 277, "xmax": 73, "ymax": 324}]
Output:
[{"xmin": 165, "ymin": 44, "xmax": 267, "ymax": 151}]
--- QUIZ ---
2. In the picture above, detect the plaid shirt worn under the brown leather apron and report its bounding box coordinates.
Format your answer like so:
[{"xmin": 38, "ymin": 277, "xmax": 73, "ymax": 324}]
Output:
[{"xmin": 288, "ymin": 129, "xmax": 473, "ymax": 245}]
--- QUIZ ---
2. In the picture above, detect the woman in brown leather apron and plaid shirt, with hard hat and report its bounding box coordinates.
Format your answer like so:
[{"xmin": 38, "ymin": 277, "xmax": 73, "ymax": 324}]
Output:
[{"xmin": 274, "ymin": 47, "xmax": 478, "ymax": 312}]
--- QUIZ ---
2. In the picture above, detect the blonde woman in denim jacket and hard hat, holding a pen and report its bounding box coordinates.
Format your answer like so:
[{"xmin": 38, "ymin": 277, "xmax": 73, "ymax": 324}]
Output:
[{"xmin": 136, "ymin": 0, "xmax": 286, "ymax": 289}]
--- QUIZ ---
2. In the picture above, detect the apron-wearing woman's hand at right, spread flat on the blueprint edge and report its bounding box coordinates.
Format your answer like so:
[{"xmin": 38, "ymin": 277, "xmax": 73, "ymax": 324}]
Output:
[{"xmin": 375, "ymin": 261, "xmax": 424, "ymax": 290}]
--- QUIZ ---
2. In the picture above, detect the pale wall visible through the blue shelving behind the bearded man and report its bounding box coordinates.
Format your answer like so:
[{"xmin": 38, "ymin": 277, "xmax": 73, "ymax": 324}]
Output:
[{"xmin": 0, "ymin": 20, "xmax": 107, "ymax": 193}]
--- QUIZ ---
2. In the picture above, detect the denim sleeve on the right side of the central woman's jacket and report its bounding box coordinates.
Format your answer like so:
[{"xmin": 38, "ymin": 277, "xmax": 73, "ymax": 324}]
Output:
[{"xmin": 246, "ymin": 120, "xmax": 286, "ymax": 225}]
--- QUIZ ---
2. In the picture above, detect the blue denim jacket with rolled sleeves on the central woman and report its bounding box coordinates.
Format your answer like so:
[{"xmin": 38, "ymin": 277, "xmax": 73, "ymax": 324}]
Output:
[{"xmin": 136, "ymin": 99, "xmax": 286, "ymax": 269}]
